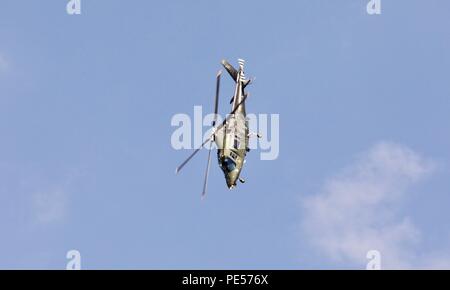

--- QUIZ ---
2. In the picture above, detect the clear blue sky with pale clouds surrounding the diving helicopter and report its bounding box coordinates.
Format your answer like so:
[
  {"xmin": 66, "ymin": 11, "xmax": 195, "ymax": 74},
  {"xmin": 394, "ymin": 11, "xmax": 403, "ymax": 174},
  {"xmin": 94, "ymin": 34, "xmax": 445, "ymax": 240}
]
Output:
[{"xmin": 0, "ymin": 0, "xmax": 450, "ymax": 269}]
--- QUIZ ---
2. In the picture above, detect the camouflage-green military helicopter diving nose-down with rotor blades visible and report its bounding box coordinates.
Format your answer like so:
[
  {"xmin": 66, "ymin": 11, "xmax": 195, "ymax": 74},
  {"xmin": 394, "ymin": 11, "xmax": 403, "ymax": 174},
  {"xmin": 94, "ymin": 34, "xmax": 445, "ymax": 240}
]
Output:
[{"xmin": 175, "ymin": 59, "xmax": 261, "ymax": 198}]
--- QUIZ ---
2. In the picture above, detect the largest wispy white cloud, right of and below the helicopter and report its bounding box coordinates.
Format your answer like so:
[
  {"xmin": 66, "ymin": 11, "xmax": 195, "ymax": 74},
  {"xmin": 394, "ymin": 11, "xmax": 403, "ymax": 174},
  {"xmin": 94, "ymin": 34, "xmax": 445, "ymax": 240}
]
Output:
[{"xmin": 302, "ymin": 142, "xmax": 449, "ymax": 268}]
